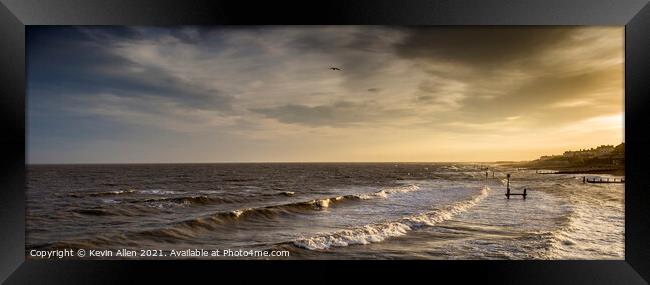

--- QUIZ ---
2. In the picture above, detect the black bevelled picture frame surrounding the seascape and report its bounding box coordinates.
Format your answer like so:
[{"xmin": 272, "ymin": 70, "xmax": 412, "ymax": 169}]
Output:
[{"xmin": 0, "ymin": 0, "xmax": 650, "ymax": 284}]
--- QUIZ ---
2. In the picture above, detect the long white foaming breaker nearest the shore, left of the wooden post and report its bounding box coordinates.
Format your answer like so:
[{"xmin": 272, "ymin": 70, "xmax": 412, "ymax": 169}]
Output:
[{"xmin": 293, "ymin": 184, "xmax": 489, "ymax": 250}]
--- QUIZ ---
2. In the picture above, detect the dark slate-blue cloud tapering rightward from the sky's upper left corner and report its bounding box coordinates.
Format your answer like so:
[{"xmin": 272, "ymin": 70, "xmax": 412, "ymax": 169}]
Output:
[{"xmin": 29, "ymin": 27, "xmax": 232, "ymax": 113}]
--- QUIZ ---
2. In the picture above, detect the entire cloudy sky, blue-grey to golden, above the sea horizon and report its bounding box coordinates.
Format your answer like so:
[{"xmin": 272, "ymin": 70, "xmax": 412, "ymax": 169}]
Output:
[{"xmin": 27, "ymin": 26, "xmax": 624, "ymax": 164}]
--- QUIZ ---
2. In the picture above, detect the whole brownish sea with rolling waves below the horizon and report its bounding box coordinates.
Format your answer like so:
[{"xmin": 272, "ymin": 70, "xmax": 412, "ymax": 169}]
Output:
[{"xmin": 26, "ymin": 163, "xmax": 625, "ymax": 260}]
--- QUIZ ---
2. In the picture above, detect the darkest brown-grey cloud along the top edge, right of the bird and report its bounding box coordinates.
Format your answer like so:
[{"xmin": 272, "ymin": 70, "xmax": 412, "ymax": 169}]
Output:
[{"xmin": 396, "ymin": 27, "xmax": 576, "ymax": 70}]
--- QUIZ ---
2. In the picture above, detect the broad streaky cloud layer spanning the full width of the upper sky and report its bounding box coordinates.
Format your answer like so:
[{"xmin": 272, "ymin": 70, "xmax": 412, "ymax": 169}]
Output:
[{"xmin": 31, "ymin": 26, "xmax": 622, "ymax": 130}]
